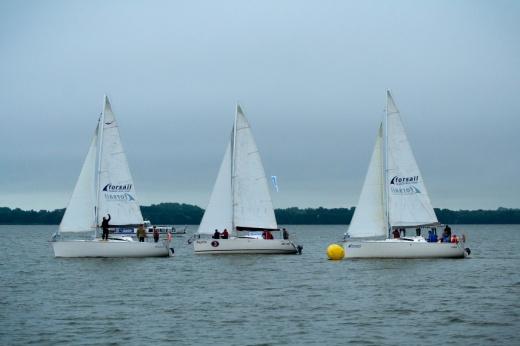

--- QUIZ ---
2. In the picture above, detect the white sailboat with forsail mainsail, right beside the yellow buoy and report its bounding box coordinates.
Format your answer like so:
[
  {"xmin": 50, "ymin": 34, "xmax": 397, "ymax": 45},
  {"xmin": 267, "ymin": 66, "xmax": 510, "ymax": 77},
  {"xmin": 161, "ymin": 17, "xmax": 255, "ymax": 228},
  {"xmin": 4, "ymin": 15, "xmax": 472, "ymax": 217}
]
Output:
[{"xmin": 344, "ymin": 90, "xmax": 470, "ymax": 258}]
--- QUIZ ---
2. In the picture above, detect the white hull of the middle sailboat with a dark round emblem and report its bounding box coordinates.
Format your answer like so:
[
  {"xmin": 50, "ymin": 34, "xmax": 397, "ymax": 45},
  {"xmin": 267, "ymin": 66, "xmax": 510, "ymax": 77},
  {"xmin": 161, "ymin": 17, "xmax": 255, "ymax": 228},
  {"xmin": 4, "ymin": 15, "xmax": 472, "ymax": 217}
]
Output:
[{"xmin": 193, "ymin": 238, "xmax": 298, "ymax": 254}]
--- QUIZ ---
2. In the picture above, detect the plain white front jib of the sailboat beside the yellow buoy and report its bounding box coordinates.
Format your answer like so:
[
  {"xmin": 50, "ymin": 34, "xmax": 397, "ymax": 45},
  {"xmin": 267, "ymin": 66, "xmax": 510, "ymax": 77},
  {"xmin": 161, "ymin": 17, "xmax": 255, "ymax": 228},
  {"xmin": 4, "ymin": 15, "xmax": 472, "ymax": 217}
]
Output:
[{"xmin": 348, "ymin": 126, "xmax": 387, "ymax": 238}]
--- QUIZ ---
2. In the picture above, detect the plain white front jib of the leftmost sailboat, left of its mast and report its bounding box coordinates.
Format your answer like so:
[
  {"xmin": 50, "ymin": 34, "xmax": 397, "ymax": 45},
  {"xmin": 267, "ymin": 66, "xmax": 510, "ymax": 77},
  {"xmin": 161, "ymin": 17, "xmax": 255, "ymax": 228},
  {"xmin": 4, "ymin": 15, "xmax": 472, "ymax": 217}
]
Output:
[{"xmin": 59, "ymin": 124, "xmax": 99, "ymax": 232}]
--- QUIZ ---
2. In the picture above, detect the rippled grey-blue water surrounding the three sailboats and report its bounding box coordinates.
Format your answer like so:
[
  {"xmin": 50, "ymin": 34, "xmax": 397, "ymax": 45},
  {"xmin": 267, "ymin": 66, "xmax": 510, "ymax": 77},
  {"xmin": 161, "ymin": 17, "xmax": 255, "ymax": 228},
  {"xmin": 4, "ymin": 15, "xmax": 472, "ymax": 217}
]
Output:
[{"xmin": 0, "ymin": 225, "xmax": 520, "ymax": 345}]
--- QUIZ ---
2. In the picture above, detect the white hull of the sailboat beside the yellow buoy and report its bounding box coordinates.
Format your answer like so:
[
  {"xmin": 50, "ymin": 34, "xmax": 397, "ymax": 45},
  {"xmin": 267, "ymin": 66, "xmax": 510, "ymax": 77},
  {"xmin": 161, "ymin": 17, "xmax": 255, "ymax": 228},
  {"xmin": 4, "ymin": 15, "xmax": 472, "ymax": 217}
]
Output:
[{"xmin": 344, "ymin": 239, "xmax": 467, "ymax": 258}]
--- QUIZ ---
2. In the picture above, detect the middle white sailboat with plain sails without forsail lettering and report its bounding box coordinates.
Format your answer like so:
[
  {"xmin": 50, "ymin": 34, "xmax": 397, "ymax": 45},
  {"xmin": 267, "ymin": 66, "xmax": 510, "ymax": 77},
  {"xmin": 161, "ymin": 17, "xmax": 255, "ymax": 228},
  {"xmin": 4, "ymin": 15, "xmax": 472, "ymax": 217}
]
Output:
[{"xmin": 193, "ymin": 105, "xmax": 302, "ymax": 254}]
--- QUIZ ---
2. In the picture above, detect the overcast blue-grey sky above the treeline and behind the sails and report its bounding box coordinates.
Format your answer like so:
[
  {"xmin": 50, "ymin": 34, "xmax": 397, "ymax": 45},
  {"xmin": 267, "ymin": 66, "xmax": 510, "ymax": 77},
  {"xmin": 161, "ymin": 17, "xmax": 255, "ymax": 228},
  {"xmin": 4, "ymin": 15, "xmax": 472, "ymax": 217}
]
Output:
[{"xmin": 0, "ymin": 0, "xmax": 520, "ymax": 209}]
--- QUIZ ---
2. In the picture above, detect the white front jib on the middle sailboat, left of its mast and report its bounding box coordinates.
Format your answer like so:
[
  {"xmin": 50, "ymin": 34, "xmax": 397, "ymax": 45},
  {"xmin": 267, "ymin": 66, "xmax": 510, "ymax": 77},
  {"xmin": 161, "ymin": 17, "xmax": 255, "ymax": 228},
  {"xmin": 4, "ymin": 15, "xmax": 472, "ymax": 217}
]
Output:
[{"xmin": 198, "ymin": 138, "xmax": 233, "ymax": 234}]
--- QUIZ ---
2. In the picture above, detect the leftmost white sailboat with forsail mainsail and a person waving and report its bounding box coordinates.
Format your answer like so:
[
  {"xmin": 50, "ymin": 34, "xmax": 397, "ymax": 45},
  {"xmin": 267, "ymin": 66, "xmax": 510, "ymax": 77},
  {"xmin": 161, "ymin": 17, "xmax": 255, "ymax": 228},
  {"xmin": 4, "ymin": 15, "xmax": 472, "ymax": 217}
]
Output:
[{"xmin": 51, "ymin": 96, "xmax": 170, "ymax": 257}]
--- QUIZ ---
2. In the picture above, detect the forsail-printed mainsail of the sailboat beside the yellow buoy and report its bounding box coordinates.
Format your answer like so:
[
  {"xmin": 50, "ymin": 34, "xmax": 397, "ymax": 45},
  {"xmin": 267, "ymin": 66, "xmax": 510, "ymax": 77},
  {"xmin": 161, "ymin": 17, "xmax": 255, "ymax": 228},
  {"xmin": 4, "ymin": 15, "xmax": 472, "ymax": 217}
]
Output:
[{"xmin": 386, "ymin": 91, "xmax": 438, "ymax": 226}]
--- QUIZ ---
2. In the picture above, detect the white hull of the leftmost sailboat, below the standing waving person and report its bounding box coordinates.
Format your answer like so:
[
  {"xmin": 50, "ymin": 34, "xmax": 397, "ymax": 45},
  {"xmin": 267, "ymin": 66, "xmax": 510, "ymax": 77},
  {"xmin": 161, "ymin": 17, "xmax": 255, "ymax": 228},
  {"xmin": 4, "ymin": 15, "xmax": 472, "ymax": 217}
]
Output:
[{"xmin": 51, "ymin": 240, "xmax": 170, "ymax": 257}]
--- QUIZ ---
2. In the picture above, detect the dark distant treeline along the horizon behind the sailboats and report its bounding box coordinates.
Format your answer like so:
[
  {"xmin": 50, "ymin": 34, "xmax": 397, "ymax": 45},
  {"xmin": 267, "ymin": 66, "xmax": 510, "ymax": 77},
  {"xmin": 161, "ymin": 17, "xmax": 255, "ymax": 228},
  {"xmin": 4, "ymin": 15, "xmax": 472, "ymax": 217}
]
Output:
[{"xmin": 0, "ymin": 203, "xmax": 520, "ymax": 225}]
